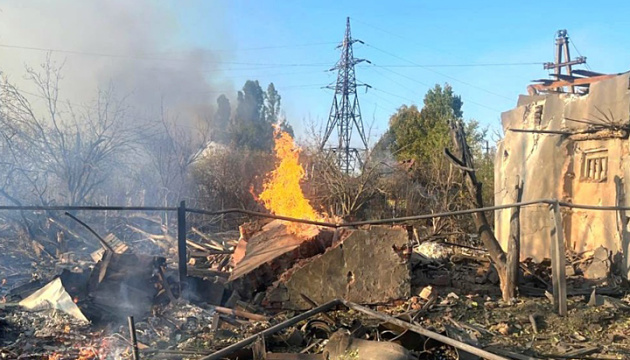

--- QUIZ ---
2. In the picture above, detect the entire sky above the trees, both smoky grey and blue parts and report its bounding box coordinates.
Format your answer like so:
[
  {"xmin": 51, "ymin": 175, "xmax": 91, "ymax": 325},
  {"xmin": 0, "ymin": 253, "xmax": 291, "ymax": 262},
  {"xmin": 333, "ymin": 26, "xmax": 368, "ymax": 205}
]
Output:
[{"xmin": 0, "ymin": 0, "xmax": 630, "ymax": 143}]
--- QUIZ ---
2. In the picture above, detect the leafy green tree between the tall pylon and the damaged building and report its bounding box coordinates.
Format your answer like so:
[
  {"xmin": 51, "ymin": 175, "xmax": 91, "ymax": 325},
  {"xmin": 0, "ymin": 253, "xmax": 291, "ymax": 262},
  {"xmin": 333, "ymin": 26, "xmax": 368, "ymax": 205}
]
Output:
[{"xmin": 374, "ymin": 84, "xmax": 493, "ymax": 240}]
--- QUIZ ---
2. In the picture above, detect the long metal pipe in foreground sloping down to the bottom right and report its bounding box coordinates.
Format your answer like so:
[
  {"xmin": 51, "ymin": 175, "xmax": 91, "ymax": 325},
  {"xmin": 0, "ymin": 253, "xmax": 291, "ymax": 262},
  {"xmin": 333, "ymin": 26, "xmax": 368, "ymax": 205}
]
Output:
[{"xmin": 341, "ymin": 300, "xmax": 508, "ymax": 360}]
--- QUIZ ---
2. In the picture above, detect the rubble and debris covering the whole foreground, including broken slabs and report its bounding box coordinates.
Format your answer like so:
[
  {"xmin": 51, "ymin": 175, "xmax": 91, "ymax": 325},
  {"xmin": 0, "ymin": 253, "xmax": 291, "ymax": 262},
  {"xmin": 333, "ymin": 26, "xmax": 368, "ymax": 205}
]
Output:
[{"xmin": 0, "ymin": 215, "xmax": 630, "ymax": 360}]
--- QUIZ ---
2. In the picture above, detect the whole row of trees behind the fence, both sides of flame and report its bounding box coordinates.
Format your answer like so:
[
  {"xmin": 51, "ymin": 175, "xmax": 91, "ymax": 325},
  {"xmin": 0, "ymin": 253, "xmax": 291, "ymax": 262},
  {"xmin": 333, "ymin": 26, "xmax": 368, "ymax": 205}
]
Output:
[{"xmin": 0, "ymin": 62, "xmax": 494, "ymax": 250}]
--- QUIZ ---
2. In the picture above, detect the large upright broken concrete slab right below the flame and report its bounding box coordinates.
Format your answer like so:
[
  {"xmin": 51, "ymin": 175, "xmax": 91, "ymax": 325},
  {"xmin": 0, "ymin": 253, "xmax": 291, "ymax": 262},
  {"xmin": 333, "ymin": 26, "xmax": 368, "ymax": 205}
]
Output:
[{"xmin": 264, "ymin": 227, "xmax": 411, "ymax": 310}]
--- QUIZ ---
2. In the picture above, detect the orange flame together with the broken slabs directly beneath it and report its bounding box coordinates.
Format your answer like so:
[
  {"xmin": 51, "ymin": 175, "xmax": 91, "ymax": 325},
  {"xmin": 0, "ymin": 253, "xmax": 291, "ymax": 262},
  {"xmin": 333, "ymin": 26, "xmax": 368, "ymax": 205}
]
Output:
[{"xmin": 229, "ymin": 129, "xmax": 410, "ymax": 309}]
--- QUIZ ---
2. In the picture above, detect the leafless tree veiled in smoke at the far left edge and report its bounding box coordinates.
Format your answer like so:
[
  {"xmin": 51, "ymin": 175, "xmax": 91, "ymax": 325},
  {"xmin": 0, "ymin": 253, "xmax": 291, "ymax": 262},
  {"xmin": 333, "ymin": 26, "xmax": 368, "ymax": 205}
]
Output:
[{"xmin": 0, "ymin": 61, "xmax": 138, "ymax": 205}]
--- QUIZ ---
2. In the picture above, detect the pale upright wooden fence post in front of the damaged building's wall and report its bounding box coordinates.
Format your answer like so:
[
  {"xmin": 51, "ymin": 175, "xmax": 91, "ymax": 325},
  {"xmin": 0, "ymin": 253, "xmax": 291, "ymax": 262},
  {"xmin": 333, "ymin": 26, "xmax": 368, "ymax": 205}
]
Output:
[{"xmin": 551, "ymin": 201, "xmax": 567, "ymax": 316}]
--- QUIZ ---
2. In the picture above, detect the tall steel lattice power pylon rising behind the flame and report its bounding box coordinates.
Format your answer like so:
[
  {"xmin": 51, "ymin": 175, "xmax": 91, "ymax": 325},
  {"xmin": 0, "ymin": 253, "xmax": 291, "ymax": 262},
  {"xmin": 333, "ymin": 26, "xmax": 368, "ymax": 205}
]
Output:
[{"xmin": 320, "ymin": 18, "xmax": 370, "ymax": 175}]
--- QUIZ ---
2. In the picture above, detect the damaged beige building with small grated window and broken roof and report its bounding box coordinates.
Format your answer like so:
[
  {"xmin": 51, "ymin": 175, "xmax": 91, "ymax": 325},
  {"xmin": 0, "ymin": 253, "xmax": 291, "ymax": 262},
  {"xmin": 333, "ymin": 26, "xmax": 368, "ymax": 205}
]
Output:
[{"xmin": 495, "ymin": 71, "xmax": 630, "ymax": 277}]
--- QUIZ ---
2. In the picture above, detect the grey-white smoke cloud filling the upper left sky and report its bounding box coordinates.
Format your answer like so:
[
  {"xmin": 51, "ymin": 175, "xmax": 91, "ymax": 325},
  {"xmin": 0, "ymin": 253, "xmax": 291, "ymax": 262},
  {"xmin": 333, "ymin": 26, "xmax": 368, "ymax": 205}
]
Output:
[{"xmin": 0, "ymin": 0, "xmax": 230, "ymax": 120}]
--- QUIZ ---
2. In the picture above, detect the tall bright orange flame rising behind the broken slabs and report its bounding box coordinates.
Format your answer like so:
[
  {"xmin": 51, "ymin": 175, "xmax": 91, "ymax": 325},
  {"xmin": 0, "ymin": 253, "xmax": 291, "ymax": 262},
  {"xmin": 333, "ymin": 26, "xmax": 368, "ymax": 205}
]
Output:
[{"xmin": 258, "ymin": 128, "xmax": 322, "ymax": 232}]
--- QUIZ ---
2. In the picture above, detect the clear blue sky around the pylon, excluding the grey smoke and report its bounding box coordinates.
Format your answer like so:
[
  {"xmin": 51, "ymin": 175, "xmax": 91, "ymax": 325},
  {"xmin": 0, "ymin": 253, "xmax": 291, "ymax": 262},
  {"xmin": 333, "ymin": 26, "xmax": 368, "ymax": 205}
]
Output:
[{"xmin": 167, "ymin": 0, "xmax": 630, "ymax": 145}]
